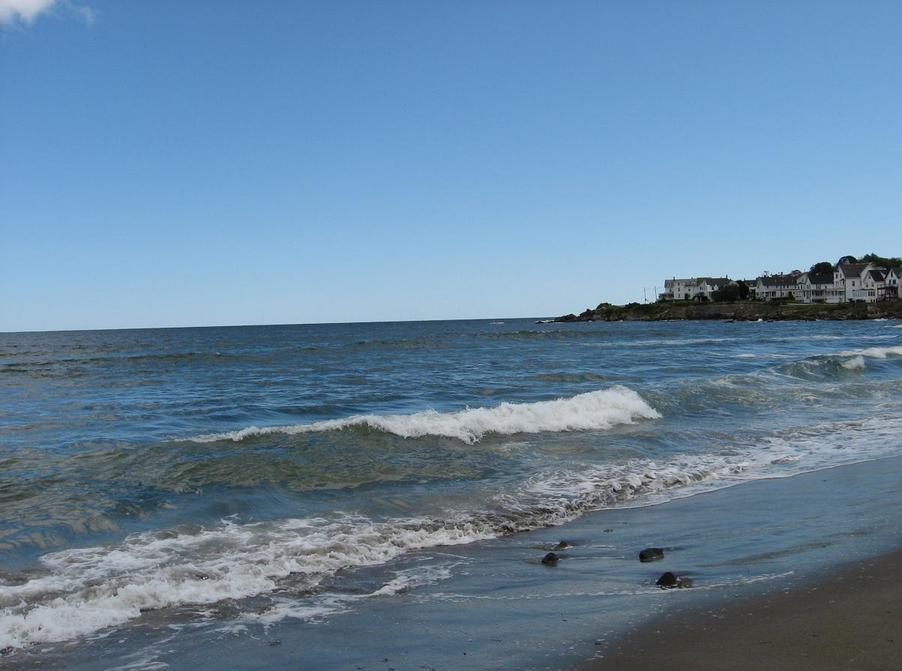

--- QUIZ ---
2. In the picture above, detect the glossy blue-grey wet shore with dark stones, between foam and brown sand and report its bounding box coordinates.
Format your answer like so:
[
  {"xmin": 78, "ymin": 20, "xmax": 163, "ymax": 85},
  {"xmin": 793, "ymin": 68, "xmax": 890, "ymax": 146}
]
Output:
[{"xmin": 7, "ymin": 455, "xmax": 902, "ymax": 671}]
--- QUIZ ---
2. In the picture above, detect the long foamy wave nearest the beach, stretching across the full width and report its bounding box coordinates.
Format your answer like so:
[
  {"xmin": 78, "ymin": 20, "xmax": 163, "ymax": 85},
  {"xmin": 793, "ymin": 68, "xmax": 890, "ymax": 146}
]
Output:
[{"xmin": 0, "ymin": 417, "xmax": 902, "ymax": 647}]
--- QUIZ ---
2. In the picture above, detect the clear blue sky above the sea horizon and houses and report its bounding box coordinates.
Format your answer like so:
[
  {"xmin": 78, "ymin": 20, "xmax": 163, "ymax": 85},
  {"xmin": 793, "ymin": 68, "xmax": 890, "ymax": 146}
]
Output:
[{"xmin": 0, "ymin": 0, "xmax": 902, "ymax": 330}]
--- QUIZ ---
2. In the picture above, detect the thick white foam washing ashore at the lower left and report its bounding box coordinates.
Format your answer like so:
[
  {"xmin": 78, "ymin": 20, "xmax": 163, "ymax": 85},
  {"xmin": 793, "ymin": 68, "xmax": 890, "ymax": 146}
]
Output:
[{"xmin": 0, "ymin": 516, "xmax": 499, "ymax": 648}]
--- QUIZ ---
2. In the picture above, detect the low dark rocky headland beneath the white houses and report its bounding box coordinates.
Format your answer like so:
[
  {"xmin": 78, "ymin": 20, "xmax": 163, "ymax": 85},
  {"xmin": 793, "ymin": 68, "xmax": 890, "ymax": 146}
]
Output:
[{"xmin": 554, "ymin": 300, "xmax": 902, "ymax": 322}]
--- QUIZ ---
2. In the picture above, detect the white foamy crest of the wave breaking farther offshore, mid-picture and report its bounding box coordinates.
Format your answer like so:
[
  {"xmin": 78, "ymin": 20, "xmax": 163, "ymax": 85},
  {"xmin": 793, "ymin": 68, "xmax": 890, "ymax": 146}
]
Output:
[{"xmin": 191, "ymin": 386, "xmax": 661, "ymax": 444}]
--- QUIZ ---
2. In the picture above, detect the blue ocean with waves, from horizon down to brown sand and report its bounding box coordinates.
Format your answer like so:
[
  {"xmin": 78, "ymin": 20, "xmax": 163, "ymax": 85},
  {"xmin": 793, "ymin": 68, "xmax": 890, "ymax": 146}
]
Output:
[{"xmin": 0, "ymin": 319, "xmax": 902, "ymax": 669}]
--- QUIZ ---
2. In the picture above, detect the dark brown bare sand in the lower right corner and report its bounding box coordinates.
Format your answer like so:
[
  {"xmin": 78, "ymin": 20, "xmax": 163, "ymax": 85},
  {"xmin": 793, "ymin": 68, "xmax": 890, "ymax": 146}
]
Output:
[{"xmin": 584, "ymin": 551, "xmax": 902, "ymax": 671}]
